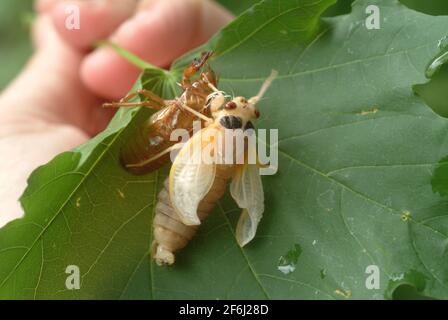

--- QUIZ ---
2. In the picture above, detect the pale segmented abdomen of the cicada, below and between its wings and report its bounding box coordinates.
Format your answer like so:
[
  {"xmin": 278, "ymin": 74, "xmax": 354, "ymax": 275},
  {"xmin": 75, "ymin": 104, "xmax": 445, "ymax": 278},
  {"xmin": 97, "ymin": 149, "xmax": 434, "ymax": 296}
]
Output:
[{"xmin": 151, "ymin": 164, "xmax": 236, "ymax": 265}]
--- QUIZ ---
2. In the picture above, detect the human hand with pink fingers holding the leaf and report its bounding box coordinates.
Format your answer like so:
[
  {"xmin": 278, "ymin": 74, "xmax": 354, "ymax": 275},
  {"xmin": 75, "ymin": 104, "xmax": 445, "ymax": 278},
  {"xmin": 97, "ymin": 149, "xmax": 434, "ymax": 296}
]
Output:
[{"xmin": 0, "ymin": 0, "xmax": 232, "ymax": 226}]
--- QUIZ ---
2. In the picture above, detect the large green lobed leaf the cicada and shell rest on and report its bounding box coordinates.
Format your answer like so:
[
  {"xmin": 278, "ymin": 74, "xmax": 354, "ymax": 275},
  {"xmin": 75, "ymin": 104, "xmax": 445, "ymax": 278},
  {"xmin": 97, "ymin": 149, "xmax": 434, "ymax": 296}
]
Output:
[{"xmin": 0, "ymin": 0, "xmax": 448, "ymax": 299}]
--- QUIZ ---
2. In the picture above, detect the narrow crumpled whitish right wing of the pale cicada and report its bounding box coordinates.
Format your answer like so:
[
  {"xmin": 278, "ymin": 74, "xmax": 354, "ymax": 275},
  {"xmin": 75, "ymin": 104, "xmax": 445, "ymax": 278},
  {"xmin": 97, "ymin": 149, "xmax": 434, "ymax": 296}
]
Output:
[{"xmin": 230, "ymin": 164, "xmax": 264, "ymax": 247}]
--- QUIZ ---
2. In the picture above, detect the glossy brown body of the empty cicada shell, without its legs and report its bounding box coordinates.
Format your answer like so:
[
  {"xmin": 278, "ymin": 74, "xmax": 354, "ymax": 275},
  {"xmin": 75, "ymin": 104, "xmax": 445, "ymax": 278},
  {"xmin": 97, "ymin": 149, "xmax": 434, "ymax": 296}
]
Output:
[{"xmin": 121, "ymin": 69, "xmax": 216, "ymax": 175}]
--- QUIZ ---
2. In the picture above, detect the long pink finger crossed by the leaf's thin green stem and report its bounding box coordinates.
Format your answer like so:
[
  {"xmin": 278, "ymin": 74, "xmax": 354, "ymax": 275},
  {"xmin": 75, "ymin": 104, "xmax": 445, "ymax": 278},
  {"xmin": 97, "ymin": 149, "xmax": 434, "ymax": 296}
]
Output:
[{"xmin": 81, "ymin": 0, "xmax": 232, "ymax": 99}]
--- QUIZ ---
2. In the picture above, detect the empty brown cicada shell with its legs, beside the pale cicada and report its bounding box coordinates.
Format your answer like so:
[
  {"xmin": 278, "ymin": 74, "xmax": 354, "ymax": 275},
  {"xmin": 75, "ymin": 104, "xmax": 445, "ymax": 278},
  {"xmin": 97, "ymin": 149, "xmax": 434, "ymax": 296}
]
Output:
[{"xmin": 104, "ymin": 51, "xmax": 217, "ymax": 174}]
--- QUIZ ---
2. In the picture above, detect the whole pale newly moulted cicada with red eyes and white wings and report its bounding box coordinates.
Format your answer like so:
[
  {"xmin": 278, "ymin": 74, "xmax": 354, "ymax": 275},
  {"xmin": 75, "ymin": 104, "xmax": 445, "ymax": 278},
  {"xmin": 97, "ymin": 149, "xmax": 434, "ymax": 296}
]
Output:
[{"xmin": 151, "ymin": 72, "xmax": 275, "ymax": 265}]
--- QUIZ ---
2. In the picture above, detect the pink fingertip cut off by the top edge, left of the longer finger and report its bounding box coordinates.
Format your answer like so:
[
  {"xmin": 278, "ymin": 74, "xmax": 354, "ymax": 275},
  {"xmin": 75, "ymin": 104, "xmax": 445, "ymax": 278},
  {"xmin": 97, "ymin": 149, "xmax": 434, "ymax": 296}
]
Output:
[{"xmin": 47, "ymin": 0, "xmax": 137, "ymax": 49}]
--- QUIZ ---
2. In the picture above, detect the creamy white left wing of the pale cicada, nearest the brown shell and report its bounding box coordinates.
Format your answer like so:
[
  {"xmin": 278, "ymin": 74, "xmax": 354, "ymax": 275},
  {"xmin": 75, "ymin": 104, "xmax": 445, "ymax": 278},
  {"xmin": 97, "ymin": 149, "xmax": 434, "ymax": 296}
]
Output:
[{"xmin": 169, "ymin": 128, "xmax": 216, "ymax": 225}]
